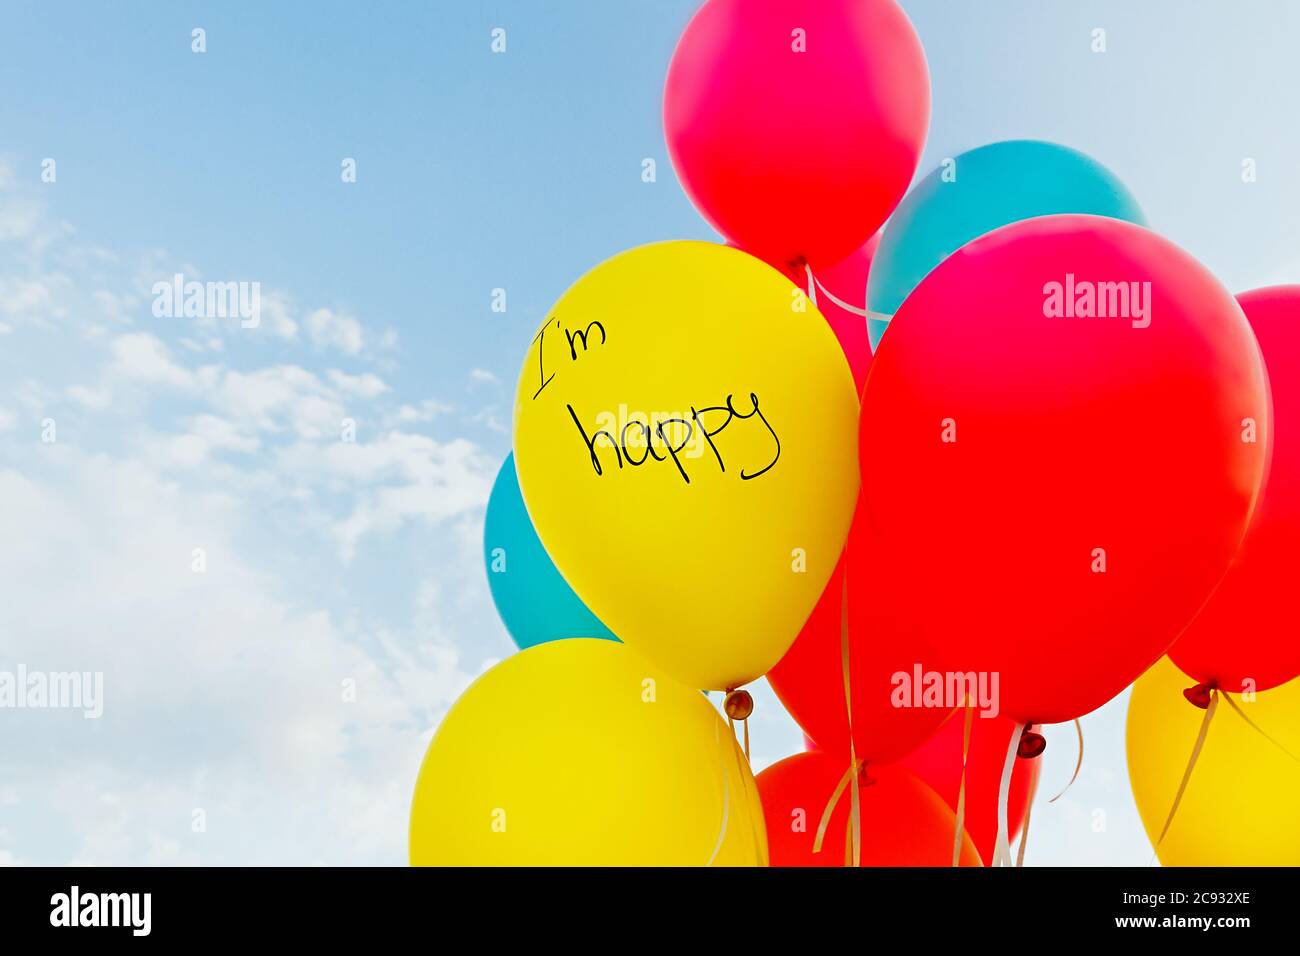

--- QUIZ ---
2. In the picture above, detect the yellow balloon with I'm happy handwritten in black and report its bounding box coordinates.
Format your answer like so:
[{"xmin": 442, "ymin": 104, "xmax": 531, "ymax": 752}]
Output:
[{"xmin": 515, "ymin": 242, "xmax": 858, "ymax": 691}]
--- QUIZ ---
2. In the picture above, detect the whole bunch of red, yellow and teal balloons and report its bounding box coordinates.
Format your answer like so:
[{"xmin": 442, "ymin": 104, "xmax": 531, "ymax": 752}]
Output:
[{"xmin": 411, "ymin": 0, "xmax": 1300, "ymax": 866}]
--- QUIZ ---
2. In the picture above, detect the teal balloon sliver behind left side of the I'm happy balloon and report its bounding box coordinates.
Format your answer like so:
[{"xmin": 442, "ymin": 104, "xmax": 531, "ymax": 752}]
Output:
[{"xmin": 484, "ymin": 455, "xmax": 618, "ymax": 648}]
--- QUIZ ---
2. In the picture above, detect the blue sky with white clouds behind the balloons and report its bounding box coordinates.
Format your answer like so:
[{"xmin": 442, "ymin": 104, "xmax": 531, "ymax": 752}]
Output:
[{"xmin": 0, "ymin": 0, "xmax": 1300, "ymax": 864}]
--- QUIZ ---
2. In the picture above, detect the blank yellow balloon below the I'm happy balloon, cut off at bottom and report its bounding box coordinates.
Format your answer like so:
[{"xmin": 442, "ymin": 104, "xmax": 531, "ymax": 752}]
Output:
[{"xmin": 411, "ymin": 639, "xmax": 767, "ymax": 866}]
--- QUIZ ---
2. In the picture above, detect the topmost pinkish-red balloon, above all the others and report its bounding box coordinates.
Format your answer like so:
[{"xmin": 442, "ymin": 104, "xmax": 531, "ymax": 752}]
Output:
[{"xmin": 663, "ymin": 0, "xmax": 930, "ymax": 268}]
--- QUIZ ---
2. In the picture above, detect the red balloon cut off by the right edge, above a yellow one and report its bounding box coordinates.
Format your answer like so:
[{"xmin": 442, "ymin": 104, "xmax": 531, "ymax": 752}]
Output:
[{"xmin": 1169, "ymin": 285, "xmax": 1300, "ymax": 693}]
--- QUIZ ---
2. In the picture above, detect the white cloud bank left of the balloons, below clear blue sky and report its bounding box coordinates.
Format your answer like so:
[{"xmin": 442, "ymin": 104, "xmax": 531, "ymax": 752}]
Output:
[{"xmin": 0, "ymin": 151, "xmax": 508, "ymax": 865}]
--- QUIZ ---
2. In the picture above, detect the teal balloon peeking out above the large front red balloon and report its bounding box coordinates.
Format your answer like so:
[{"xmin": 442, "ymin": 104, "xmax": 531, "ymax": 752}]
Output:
[{"xmin": 867, "ymin": 139, "xmax": 1147, "ymax": 352}]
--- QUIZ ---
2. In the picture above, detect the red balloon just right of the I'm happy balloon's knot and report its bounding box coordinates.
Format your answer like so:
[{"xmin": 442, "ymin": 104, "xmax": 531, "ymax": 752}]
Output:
[{"xmin": 767, "ymin": 535, "xmax": 951, "ymax": 773}]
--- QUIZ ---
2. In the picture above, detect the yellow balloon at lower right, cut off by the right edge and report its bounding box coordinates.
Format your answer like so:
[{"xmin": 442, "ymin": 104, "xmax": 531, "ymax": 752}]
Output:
[{"xmin": 1127, "ymin": 657, "xmax": 1300, "ymax": 866}]
